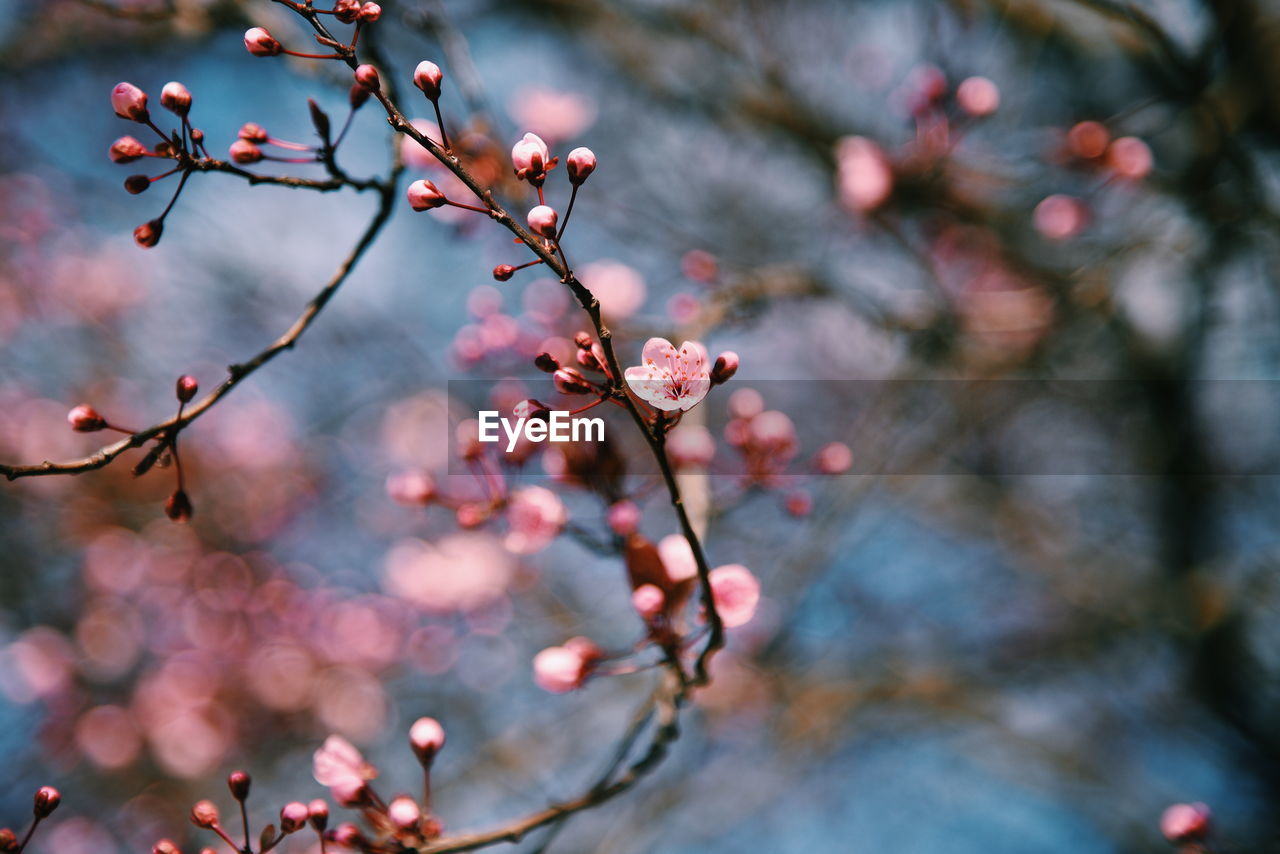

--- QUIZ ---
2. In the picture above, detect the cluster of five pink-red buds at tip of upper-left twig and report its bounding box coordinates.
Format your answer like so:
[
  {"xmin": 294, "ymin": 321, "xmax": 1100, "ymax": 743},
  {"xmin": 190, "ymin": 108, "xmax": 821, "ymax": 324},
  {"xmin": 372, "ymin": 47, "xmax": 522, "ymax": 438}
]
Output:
[{"xmin": 108, "ymin": 81, "xmax": 209, "ymax": 248}]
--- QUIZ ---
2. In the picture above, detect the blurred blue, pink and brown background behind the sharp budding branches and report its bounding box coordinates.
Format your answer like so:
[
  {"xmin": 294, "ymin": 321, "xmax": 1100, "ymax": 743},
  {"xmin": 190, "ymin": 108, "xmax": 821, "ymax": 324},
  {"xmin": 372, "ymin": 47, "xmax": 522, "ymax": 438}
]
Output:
[{"xmin": 0, "ymin": 0, "xmax": 1280, "ymax": 854}]
